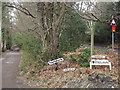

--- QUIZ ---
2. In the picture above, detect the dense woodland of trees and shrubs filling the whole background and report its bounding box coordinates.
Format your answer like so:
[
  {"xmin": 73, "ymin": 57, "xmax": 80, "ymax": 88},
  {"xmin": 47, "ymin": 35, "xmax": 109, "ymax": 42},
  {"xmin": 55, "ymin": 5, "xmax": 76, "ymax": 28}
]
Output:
[{"xmin": 2, "ymin": 1, "xmax": 120, "ymax": 69}]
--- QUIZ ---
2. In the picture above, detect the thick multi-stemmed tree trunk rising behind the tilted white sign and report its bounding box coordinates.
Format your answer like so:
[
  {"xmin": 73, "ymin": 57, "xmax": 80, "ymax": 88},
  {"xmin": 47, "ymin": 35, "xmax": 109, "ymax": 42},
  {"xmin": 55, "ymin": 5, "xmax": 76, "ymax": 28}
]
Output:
[{"xmin": 37, "ymin": 2, "xmax": 65, "ymax": 61}]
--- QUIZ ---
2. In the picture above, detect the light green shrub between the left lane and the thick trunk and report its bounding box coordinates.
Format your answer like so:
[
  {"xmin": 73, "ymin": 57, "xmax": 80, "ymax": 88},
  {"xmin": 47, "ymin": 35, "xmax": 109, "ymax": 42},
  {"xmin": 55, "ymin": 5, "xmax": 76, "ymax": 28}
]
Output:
[{"xmin": 14, "ymin": 33, "xmax": 44, "ymax": 72}]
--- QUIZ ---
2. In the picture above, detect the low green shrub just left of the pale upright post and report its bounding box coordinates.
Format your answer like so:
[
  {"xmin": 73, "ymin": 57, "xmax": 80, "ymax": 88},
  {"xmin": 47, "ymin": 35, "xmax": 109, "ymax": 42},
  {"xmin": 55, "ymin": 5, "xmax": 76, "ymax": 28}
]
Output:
[{"xmin": 70, "ymin": 47, "xmax": 90, "ymax": 67}]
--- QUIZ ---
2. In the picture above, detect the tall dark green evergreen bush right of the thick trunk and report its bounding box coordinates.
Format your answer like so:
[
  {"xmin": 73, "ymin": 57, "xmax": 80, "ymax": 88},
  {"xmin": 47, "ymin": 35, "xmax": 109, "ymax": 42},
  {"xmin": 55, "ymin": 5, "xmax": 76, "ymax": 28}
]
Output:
[{"xmin": 59, "ymin": 10, "xmax": 87, "ymax": 51}]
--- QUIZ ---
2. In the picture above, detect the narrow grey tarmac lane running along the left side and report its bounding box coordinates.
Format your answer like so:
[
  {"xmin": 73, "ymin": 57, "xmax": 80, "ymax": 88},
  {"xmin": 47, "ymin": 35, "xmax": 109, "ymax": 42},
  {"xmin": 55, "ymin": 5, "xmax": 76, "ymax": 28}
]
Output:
[{"xmin": 1, "ymin": 51, "xmax": 25, "ymax": 88}]
